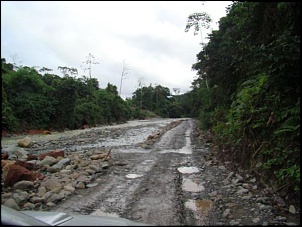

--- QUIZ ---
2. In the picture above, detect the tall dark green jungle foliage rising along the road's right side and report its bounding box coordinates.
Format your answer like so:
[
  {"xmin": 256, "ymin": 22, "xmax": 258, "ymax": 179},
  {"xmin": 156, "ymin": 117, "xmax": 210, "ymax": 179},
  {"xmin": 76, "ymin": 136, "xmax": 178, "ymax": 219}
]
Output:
[{"xmin": 186, "ymin": 2, "xmax": 300, "ymax": 199}]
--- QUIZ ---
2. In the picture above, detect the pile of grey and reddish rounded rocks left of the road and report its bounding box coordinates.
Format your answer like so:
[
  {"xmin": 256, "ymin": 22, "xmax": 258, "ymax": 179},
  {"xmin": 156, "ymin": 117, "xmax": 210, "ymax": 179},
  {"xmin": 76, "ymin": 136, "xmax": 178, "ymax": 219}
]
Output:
[{"xmin": 1, "ymin": 138, "xmax": 111, "ymax": 210}]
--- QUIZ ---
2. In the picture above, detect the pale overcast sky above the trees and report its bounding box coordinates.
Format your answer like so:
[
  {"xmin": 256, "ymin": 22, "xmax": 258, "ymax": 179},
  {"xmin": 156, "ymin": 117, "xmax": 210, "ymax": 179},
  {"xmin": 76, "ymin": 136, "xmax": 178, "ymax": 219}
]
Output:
[{"xmin": 1, "ymin": 1, "xmax": 231, "ymax": 98}]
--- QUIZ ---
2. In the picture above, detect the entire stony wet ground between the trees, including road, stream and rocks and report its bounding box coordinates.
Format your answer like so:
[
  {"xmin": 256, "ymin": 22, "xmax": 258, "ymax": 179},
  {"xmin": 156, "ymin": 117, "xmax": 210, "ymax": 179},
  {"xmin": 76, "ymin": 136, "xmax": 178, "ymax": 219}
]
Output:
[{"xmin": 1, "ymin": 119, "xmax": 300, "ymax": 226}]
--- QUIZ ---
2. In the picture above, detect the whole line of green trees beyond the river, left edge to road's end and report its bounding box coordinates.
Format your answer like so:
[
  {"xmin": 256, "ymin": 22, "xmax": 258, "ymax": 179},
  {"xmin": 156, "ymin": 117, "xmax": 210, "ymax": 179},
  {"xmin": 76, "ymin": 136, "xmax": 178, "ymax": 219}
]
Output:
[{"xmin": 1, "ymin": 58, "xmax": 186, "ymax": 132}]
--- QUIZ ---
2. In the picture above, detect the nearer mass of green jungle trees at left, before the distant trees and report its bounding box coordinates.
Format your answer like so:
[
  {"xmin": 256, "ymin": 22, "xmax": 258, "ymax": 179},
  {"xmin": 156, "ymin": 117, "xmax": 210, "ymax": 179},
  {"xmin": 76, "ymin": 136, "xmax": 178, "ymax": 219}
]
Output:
[{"xmin": 1, "ymin": 59, "xmax": 131, "ymax": 132}]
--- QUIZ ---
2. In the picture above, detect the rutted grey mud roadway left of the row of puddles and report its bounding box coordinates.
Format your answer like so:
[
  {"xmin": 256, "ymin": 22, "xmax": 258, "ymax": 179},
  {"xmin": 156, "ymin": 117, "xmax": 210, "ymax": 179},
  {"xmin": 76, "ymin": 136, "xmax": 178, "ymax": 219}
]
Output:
[{"xmin": 52, "ymin": 120, "xmax": 199, "ymax": 225}]
